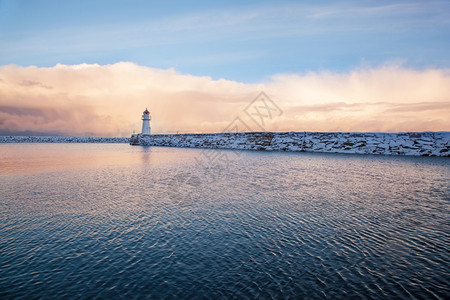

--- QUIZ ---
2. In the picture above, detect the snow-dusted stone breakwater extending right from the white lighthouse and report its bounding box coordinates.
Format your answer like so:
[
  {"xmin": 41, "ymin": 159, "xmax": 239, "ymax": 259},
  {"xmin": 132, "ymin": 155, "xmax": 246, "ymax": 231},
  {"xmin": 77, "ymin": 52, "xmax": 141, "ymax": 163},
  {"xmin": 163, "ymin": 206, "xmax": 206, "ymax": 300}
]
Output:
[{"xmin": 130, "ymin": 132, "xmax": 450, "ymax": 157}]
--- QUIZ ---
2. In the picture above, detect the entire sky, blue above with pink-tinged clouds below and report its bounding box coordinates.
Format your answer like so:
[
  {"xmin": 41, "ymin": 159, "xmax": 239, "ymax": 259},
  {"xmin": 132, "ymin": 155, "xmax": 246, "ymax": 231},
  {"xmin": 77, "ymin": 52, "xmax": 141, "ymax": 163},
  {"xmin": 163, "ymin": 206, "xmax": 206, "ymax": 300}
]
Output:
[{"xmin": 0, "ymin": 0, "xmax": 450, "ymax": 136}]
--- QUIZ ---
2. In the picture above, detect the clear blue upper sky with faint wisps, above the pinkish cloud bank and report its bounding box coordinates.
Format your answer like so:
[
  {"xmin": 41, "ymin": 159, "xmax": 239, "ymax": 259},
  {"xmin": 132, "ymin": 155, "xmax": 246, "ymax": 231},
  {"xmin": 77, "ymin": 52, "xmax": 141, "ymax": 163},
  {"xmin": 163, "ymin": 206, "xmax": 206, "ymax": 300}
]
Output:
[{"xmin": 0, "ymin": 0, "xmax": 450, "ymax": 83}]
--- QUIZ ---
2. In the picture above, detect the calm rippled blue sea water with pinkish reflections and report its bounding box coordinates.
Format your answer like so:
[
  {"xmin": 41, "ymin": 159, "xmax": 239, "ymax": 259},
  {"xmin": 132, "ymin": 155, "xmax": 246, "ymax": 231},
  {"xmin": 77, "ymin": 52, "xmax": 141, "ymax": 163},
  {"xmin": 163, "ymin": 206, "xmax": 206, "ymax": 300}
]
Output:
[{"xmin": 0, "ymin": 144, "xmax": 450, "ymax": 299}]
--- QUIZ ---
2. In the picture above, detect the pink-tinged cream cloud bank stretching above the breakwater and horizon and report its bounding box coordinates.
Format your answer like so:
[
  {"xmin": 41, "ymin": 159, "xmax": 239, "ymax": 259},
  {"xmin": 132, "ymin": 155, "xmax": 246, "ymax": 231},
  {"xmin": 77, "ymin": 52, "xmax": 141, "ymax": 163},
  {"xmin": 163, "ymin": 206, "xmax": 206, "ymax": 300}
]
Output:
[{"xmin": 0, "ymin": 62, "xmax": 450, "ymax": 136}]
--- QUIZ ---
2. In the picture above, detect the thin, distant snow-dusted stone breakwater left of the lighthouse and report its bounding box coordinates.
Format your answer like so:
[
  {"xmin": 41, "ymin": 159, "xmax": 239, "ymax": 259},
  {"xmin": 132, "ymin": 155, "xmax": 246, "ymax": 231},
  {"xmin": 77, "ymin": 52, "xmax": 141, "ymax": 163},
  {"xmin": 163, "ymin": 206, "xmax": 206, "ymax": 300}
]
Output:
[{"xmin": 0, "ymin": 136, "xmax": 130, "ymax": 143}]
